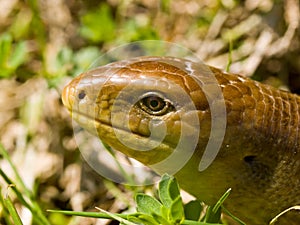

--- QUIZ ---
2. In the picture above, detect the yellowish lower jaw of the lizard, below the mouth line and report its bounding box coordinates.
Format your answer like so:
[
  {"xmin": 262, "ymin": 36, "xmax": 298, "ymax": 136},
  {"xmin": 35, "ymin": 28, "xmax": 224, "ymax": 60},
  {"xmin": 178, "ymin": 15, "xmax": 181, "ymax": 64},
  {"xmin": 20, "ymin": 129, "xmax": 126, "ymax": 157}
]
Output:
[{"xmin": 72, "ymin": 108, "xmax": 199, "ymax": 174}]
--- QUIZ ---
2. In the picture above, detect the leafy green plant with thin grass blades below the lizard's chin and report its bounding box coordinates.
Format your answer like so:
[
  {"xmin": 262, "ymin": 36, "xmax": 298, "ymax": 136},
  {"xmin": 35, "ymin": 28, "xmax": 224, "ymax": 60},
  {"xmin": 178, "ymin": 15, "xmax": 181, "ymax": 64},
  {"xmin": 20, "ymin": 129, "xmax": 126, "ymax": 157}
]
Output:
[{"xmin": 49, "ymin": 175, "xmax": 243, "ymax": 225}]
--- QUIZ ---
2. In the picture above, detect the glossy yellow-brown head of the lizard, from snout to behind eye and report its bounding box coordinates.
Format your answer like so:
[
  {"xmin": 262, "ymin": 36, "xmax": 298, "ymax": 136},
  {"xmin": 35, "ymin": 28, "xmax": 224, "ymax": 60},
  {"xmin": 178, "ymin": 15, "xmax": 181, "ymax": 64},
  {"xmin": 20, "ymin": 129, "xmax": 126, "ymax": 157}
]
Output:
[{"xmin": 62, "ymin": 57, "xmax": 226, "ymax": 173}]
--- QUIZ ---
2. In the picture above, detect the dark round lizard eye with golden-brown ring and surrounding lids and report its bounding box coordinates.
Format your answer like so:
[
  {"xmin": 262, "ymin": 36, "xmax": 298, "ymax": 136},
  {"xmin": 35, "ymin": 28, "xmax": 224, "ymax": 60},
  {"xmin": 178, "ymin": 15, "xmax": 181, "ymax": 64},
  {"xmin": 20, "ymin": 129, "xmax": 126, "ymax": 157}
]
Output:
[{"xmin": 139, "ymin": 93, "xmax": 174, "ymax": 116}]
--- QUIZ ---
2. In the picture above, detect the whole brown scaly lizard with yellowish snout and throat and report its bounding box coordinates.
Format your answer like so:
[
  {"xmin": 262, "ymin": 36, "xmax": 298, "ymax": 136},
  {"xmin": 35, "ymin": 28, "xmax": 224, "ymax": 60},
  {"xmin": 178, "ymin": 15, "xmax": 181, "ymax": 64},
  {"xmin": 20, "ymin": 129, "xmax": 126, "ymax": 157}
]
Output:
[{"xmin": 63, "ymin": 57, "xmax": 300, "ymax": 225}]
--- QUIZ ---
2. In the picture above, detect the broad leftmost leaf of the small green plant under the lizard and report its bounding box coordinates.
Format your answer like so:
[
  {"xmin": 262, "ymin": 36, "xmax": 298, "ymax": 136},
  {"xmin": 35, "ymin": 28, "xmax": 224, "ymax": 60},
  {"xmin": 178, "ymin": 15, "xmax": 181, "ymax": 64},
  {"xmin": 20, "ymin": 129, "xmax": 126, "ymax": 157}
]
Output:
[{"xmin": 135, "ymin": 194, "xmax": 162, "ymax": 215}]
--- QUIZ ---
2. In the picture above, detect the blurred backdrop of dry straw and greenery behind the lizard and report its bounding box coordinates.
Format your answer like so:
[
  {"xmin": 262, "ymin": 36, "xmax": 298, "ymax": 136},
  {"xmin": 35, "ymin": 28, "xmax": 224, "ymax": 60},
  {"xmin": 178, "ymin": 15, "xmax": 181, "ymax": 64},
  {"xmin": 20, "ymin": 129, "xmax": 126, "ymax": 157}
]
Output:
[{"xmin": 0, "ymin": 0, "xmax": 300, "ymax": 225}]
